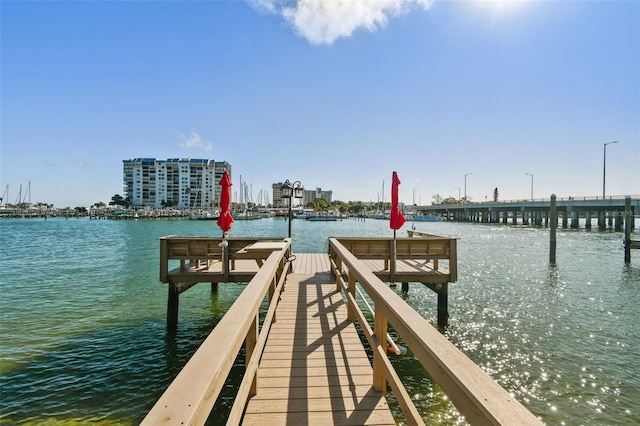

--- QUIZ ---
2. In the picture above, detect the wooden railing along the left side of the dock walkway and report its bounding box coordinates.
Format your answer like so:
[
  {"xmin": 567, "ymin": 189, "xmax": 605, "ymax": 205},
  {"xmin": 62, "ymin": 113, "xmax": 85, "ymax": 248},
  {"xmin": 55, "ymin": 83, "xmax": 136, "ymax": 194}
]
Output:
[{"xmin": 141, "ymin": 250, "xmax": 289, "ymax": 425}]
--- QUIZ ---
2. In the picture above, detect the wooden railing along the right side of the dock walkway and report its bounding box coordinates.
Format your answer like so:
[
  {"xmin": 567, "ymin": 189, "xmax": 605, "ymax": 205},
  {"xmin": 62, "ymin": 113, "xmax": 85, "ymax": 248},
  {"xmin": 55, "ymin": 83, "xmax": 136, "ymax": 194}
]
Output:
[{"xmin": 329, "ymin": 238, "xmax": 541, "ymax": 425}]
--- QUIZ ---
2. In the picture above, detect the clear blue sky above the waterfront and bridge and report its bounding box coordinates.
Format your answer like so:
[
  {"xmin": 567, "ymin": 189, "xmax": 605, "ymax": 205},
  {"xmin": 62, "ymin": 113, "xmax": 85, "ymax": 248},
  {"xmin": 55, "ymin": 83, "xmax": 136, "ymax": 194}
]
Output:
[{"xmin": 0, "ymin": 0, "xmax": 640, "ymax": 207}]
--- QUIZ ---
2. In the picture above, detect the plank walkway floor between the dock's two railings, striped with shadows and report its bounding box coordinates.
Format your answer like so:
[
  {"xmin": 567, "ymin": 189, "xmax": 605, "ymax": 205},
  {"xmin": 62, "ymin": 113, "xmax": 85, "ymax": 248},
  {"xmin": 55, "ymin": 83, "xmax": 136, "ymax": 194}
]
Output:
[{"xmin": 243, "ymin": 254, "xmax": 396, "ymax": 425}]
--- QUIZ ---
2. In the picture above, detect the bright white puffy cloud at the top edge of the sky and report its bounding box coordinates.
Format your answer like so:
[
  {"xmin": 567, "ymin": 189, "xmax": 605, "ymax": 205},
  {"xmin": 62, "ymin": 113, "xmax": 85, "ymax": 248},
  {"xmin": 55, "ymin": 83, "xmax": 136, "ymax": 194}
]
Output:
[{"xmin": 255, "ymin": 0, "xmax": 434, "ymax": 44}]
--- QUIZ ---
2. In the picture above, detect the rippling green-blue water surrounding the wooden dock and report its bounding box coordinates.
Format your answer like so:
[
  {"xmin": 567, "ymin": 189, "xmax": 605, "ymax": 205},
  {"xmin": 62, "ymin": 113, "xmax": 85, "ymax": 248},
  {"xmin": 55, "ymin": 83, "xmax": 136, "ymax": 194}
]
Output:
[{"xmin": 0, "ymin": 219, "xmax": 640, "ymax": 425}]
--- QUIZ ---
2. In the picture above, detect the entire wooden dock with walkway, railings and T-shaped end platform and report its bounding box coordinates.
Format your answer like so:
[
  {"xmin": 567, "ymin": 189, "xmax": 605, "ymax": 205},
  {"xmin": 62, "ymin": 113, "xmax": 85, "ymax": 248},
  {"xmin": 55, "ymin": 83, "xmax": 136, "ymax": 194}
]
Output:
[{"xmin": 142, "ymin": 234, "xmax": 541, "ymax": 425}]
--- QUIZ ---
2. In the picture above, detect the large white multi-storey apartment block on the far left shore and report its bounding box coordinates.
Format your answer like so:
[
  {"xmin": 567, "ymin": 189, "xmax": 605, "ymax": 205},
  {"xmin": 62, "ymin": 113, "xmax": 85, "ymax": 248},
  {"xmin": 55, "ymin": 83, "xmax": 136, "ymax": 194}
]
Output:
[{"xmin": 122, "ymin": 158, "xmax": 231, "ymax": 209}]
